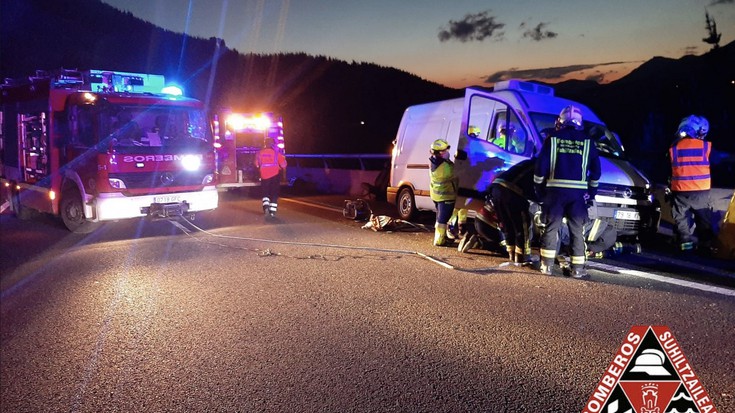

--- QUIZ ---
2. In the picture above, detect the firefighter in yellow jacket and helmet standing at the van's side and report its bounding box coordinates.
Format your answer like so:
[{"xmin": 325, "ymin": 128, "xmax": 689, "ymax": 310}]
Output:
[{"xmin": 429, "ymin": 139, "xmax": 458, "ymax": 246}]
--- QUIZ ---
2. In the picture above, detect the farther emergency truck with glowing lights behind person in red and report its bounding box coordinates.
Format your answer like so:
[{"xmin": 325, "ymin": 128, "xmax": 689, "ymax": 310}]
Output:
[{"xmin": 214, "ymin": 110, "xmax": 286, "ymax": 190}]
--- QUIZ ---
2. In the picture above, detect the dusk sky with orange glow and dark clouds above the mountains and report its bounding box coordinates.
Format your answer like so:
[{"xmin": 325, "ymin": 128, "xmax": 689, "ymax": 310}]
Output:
[{"xmin": 103, "ymin": 0, "xmax": 735, "ymax": 88}]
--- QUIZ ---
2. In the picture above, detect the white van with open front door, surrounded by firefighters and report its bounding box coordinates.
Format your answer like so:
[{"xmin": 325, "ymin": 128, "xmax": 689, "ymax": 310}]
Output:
[{"xmin": 387, "ymin": 80, "xmax": 660, "ymax": 237}]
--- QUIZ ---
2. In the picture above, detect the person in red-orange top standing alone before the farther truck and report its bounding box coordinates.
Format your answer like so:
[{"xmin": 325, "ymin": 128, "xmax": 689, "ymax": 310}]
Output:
[{"xmin": 255, "ymin": 138, "xmax": 286, "ymax": 218}]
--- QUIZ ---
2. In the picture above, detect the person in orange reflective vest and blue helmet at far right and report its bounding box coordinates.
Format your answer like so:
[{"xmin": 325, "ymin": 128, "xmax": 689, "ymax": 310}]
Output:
[{"xmin": 668, "ymin": 115, "xmax": 714, "ymax": 252}]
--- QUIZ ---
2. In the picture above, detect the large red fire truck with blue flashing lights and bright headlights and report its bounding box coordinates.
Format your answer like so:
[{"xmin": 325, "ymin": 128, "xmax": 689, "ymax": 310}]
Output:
[{"xmin": 0, "ymin": 69, "xmax": 218, "ymax": 233}]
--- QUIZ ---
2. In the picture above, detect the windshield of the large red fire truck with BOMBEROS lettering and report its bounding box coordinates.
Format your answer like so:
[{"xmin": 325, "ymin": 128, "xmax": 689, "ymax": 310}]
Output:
[{"xmin": 99, "ymin": 105, "xmax": 212, "ymax": 149}]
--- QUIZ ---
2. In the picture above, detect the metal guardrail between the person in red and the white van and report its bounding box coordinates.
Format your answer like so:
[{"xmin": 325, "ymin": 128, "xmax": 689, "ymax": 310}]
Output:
[{"xmin": 286, "ymin": 153, "xmax": 390, "ymax": 171}]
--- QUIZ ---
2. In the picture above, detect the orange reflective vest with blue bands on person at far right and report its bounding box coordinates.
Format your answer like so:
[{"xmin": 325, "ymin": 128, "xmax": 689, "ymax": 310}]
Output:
[{"xmin": 669, "ymin": 137, "xmax": 712, "ymax": 191}]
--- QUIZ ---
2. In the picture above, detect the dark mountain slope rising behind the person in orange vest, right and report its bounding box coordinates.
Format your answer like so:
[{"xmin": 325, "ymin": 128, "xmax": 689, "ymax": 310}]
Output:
[{"xmin": 555, "ymin": 42, "xmax": 735, "ymax": 183}]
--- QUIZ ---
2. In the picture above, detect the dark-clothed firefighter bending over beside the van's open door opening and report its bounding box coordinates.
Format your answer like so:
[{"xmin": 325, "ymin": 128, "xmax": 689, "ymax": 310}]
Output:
[{"xmin": 490, "ymin": 158, "xmax": 536, "ymax": 265}]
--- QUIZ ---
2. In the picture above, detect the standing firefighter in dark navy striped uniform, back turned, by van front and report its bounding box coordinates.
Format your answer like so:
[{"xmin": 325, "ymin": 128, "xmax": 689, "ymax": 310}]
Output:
[{"xmin": 533, "ymin": 105, "xmax": 600, "ymax": 279}]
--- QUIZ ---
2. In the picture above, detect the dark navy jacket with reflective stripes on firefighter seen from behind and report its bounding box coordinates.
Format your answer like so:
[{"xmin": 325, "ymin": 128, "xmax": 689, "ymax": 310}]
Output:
[{"xmin": 533, "ymin": 128, "xmax": 601, "ymax": 190}]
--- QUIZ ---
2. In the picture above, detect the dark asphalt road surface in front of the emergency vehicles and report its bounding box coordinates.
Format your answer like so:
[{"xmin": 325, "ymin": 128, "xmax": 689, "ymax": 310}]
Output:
[{"xmin": 0, "ymin": 195, "xmax": 735, "ymax": 412}]
